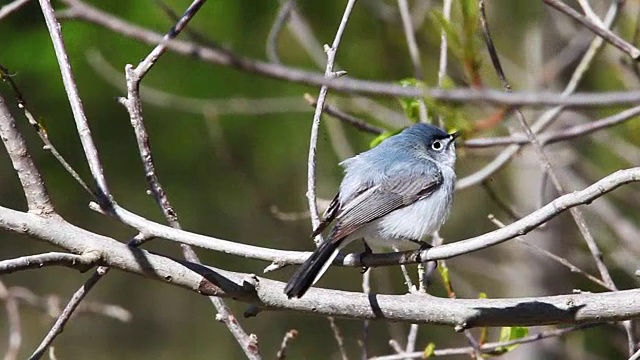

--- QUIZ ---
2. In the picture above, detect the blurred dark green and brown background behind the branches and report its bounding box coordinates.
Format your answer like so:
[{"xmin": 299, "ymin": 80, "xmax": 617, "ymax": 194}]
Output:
[{"xmin": 0, "ymin": 0, "xmax": 640, "ymax": 359}]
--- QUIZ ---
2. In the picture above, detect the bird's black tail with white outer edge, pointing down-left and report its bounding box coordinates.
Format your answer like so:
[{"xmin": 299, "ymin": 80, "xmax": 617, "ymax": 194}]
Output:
[{"xmin": 284, "ymin": 239, "xmax": 342, "ymax": 299}]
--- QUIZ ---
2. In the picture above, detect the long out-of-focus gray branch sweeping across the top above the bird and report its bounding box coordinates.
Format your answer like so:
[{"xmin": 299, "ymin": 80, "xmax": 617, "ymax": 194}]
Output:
[{"xmin": 60, "ymin": 0, "xmax": 640, "ymax": 107}]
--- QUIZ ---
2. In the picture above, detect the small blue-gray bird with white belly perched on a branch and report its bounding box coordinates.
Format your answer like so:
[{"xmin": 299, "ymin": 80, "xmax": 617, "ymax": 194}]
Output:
[{"xmin": 284, "ymin": 124, "xmax": 458, "ymax": 298}]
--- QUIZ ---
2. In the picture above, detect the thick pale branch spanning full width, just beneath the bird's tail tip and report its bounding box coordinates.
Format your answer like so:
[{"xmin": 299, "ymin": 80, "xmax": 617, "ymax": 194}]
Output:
[{"xmin": 0, "ymin": 207, "xmax": 640, "ymax": 330}]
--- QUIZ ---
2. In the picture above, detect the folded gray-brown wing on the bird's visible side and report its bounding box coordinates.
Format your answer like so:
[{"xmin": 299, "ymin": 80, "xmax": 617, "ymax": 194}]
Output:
[{"xmin": 330, "ymin": 168, "xmax": 443, "ymax": 241}]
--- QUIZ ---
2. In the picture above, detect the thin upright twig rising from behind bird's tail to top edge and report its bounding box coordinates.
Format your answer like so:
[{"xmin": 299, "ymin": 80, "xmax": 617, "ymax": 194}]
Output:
[{"xmin": 307, "ymin": 0, "xmax": 356, "ymax": 245}]
